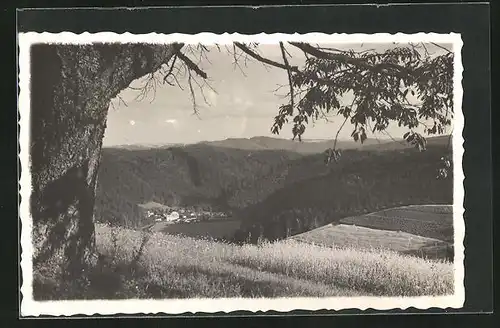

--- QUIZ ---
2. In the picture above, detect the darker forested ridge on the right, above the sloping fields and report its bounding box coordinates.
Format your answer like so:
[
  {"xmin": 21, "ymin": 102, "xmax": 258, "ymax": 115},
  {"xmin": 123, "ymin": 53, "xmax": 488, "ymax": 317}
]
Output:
[{"xmin": 236, "ymin": 145, "xmax": 453, "ymax": 241}]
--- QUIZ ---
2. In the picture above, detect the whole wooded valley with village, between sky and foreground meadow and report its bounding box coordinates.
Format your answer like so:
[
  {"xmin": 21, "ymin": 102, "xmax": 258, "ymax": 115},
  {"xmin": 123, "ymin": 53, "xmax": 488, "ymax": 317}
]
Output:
[{"xmin": 96, "ymin": 137, "xmax": 452, "ymax": 252}]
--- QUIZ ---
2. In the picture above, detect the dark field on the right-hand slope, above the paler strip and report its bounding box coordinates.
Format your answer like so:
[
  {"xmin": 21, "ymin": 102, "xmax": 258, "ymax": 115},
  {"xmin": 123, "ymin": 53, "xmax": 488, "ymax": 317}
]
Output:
[{"xmin": 340, "ymin": 205, "xmax": 453, "ymax": 243}]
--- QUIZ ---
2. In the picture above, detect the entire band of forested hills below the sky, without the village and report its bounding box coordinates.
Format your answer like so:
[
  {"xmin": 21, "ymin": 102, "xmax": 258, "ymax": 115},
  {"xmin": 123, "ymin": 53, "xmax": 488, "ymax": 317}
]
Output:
[{"xmin": 96, "ymin": 137, "xmax": 451, "ymax": 231}]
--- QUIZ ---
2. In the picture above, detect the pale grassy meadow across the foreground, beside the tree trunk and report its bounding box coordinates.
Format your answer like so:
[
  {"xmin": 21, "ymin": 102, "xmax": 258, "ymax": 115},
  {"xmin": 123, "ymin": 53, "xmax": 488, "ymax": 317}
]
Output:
[{"xmin": 34, "ymin": 224, "xmax": 453, "ymax": 299}]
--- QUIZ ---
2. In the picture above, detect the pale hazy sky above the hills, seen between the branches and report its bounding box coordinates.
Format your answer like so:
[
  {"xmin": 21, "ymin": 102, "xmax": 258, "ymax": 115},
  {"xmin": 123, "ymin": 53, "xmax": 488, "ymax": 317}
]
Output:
[{"xmin": 104, "ymin": 44, "xmax": 451, "ymax": 146}]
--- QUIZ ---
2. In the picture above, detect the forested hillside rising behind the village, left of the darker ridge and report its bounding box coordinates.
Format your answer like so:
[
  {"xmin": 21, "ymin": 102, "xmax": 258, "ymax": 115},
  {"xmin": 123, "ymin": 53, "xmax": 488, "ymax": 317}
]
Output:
[{"xmin": 96, "ymin": 144, "xmax": 302, "ymax": 227}]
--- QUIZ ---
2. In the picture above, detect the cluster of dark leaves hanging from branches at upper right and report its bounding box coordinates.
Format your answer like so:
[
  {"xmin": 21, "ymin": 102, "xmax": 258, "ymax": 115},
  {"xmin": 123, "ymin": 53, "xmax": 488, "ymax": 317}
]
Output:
[{"xmin": 271, "ymin": 46, "xmax": 453, "ymax": 148}]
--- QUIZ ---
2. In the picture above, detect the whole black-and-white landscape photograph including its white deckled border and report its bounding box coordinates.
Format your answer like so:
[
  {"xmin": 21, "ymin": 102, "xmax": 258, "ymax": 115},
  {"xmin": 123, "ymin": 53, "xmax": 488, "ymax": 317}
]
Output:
[{"xmin": 19, "ymin": 33, "xmax": 465, "ymax": 315}]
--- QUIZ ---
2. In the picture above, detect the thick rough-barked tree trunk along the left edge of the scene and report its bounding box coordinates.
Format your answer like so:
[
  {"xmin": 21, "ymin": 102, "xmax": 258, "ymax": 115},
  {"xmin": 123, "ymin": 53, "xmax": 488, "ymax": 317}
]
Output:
[{"xmin": 30, "ymin": 44, "xmax": 182, "ymax": 297}]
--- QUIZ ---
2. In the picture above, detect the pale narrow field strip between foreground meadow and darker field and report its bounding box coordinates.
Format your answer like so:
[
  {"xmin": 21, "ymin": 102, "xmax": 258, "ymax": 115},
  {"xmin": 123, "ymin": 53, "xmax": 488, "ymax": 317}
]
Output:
[{"xmin": 291, "ymin": 224, "xmax": 448, "ymax": 259}]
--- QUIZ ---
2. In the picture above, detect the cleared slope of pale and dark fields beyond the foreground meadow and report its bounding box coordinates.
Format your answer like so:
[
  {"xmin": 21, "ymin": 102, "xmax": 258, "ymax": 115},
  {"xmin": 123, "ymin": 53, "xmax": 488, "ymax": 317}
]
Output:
[{"xmin": 290, "ymin": 205, "xmax": 453, "ymax": 261}]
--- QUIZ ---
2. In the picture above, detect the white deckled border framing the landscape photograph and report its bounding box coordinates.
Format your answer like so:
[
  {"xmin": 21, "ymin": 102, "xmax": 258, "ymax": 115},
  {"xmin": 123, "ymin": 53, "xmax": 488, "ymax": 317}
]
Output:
[{"xmin": 18, "ymin": 32, "xmax": 465, "ymax": 316}]
